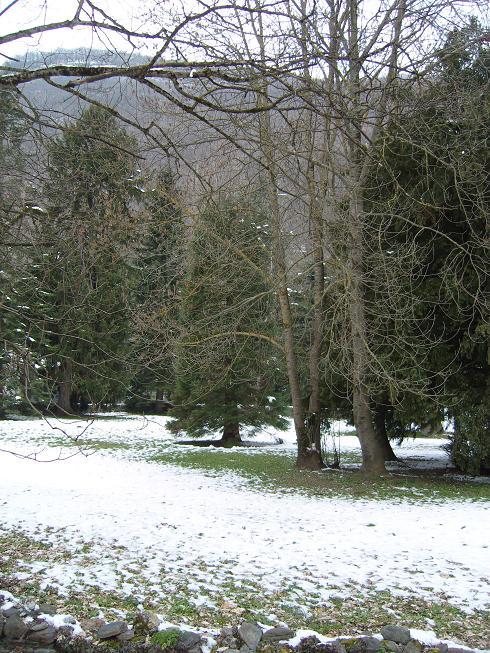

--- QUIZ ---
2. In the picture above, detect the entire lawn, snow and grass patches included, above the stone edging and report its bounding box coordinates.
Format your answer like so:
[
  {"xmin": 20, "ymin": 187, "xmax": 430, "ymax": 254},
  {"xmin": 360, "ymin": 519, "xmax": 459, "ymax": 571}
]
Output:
[{"xmin": 0, "ymin": 416, "xmax": 490, "ymax": 648}]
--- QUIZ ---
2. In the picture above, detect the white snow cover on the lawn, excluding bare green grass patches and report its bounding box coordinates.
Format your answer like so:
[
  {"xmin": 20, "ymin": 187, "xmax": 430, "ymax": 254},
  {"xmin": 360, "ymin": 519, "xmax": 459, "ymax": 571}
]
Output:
[{"xmin": 0, "ymin": 417, "xmax": 490, "ymax": 611}]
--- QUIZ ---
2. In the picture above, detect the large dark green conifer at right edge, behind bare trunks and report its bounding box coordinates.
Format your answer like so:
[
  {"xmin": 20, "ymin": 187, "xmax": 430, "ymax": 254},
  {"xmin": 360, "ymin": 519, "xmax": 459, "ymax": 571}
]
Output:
[{"xmin": 362, "ymin": 23, "xmax": 490, "ymax": 471}]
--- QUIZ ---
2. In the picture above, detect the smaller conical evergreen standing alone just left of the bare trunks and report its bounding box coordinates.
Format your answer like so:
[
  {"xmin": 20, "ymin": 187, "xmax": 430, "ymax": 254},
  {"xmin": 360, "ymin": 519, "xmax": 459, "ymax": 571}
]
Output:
[{"xmin": 172, "ymin": 197, "xmax": 287, "ymax": 445}]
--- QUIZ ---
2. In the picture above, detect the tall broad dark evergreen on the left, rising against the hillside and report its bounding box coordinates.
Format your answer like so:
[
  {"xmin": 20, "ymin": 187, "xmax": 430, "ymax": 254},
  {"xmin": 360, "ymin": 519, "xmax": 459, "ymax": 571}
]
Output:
[{"xmin": 27, "ymin": 107, "xmax": 136, "ymax": 413}]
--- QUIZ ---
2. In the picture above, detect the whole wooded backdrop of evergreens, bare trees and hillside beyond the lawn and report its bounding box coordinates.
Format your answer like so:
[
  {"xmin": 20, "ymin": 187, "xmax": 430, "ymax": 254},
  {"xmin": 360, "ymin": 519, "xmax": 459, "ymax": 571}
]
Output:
[{"xmin": 0, "ymin": 5, "xmax": 490, "ymax": 474}]
